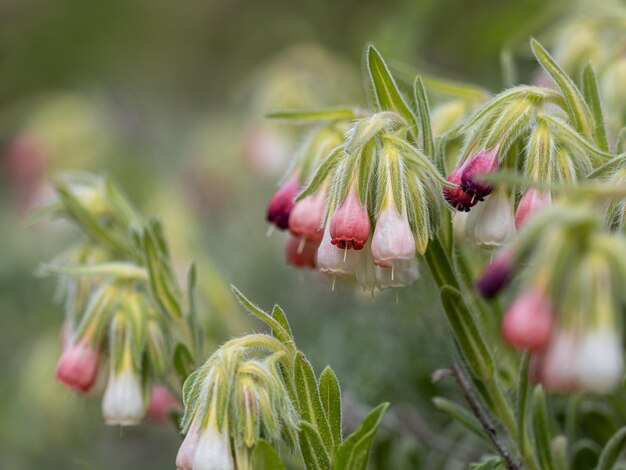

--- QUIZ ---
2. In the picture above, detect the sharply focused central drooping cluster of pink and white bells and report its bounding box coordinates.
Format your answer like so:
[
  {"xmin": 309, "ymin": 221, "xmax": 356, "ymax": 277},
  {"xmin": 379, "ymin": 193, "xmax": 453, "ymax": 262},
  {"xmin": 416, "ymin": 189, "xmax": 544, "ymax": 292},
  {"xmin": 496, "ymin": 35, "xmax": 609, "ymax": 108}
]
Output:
[{"xmin": 267, "ymin": 48, "xmax": 448, "ymax": 291}]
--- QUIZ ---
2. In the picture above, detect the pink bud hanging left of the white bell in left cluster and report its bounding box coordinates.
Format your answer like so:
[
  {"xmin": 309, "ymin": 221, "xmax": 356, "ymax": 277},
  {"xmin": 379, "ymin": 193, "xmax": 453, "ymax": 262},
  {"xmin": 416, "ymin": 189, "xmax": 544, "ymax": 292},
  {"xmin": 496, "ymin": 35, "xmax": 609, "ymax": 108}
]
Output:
[{"xmin": 56, "ymin": 339, "xmax": 100, "ymax": 393}]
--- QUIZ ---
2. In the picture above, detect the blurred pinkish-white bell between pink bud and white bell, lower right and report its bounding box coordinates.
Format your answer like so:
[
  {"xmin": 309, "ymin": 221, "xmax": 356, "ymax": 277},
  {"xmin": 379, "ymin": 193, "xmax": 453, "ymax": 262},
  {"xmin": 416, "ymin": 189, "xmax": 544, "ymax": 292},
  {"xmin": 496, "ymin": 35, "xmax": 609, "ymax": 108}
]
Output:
[{"xmin": 538, "ymin": 331, "xmax": 579, "ymax": 392}]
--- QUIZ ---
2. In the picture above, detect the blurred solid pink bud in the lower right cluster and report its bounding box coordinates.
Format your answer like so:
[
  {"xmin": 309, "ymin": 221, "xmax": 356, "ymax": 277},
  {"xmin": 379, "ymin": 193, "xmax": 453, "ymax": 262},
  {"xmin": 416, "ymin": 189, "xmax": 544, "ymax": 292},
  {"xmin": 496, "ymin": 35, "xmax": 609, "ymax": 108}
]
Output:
[{"xmin": 502, "ymin": 289, "xmax": 553, "ymax": 351}]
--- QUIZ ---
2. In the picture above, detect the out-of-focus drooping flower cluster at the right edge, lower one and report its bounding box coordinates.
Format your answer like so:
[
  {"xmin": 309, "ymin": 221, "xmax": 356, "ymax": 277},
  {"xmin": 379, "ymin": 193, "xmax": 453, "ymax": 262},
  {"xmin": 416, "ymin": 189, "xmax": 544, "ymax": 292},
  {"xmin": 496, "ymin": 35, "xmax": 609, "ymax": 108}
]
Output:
[{"xmin": 477, "ymin": 204, "xmax": 626, "ymax": 393}]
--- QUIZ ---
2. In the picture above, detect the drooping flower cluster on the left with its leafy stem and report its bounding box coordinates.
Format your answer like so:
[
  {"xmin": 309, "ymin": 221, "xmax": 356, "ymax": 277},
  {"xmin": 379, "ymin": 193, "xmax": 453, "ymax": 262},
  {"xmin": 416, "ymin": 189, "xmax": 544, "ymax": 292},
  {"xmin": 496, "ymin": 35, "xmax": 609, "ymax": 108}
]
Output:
[{"xmin": 42, "ymin": 174, "xmax": 194, "ymax": 426}]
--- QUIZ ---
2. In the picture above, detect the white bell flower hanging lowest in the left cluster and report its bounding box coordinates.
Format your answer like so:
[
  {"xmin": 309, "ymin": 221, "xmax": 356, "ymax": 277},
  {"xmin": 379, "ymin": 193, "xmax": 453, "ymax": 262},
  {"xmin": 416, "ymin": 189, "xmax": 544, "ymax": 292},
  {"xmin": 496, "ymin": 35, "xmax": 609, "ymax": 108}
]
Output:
[{"xmin": 102, "ymin": 367, "xmax": 145, "ymax": 426}]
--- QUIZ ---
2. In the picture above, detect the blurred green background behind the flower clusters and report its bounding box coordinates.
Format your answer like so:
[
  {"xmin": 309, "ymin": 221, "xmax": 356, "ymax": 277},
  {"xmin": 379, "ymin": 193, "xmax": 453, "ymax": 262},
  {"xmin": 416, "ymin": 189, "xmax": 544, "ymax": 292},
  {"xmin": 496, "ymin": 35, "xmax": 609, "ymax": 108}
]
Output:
[{"xmin": 0, "ymin": 0, "xmax": 566, "ymax": 469}]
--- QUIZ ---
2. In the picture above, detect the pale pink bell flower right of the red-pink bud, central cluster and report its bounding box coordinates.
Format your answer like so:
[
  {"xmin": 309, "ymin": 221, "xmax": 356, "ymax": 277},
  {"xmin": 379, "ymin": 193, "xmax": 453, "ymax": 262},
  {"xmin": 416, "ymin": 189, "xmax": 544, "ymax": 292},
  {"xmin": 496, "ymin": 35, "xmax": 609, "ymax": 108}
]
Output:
[{"xmin": 372, "ymin": 204, "xmax": 415, "ymax": 268}]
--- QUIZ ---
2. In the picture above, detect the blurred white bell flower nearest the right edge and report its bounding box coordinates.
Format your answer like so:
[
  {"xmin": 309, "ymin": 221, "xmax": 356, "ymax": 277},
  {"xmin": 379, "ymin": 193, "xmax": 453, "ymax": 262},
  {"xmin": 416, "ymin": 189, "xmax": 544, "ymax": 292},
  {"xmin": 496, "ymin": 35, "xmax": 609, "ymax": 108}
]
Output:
[{"xmin": 576, "ymin": 328, "xmax": 624, "ymax": 393}]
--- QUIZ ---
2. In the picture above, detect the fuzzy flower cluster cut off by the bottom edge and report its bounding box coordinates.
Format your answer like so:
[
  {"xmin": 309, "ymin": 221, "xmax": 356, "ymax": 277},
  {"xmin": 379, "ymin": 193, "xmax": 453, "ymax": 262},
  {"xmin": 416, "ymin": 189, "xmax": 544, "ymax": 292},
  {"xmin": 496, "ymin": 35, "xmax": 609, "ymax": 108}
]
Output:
[{"xmin": 176, "ymin": 337, "xmax": 298, "ymax": 470}]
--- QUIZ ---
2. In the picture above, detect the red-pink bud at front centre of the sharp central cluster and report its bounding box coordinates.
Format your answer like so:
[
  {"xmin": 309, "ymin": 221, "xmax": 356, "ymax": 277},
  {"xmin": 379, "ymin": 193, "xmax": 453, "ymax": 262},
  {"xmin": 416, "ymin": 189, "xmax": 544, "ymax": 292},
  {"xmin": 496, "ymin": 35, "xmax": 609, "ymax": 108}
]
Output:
[{"xmin": 330, "ymin": 187, "xmax": 370, "ymax": 250}]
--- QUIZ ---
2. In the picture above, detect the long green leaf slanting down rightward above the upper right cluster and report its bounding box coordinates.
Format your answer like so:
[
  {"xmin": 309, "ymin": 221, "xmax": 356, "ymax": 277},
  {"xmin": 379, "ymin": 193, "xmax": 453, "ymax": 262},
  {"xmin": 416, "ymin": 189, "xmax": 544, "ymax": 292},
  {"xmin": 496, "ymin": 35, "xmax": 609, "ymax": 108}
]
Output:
[{"xmin": 530, "ymin": 39, "xmax": 592, "ymax": 136}]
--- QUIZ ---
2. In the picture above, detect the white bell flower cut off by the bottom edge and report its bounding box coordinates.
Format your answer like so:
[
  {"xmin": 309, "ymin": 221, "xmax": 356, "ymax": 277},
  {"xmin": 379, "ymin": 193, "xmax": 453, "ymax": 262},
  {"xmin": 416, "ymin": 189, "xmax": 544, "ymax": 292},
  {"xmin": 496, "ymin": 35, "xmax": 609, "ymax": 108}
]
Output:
[{"xmin": 192, "ymin": 411, "xmax": 235, "ymax": 470}]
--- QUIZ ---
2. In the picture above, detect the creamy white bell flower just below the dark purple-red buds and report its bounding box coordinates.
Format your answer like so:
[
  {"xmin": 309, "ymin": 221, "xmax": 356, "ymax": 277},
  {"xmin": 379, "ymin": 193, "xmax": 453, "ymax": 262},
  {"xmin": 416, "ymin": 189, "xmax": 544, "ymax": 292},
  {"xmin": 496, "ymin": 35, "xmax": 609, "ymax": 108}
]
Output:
[{"xmin": 466, "ymin": 189, "xmax": 515, "ymax": 249}]
